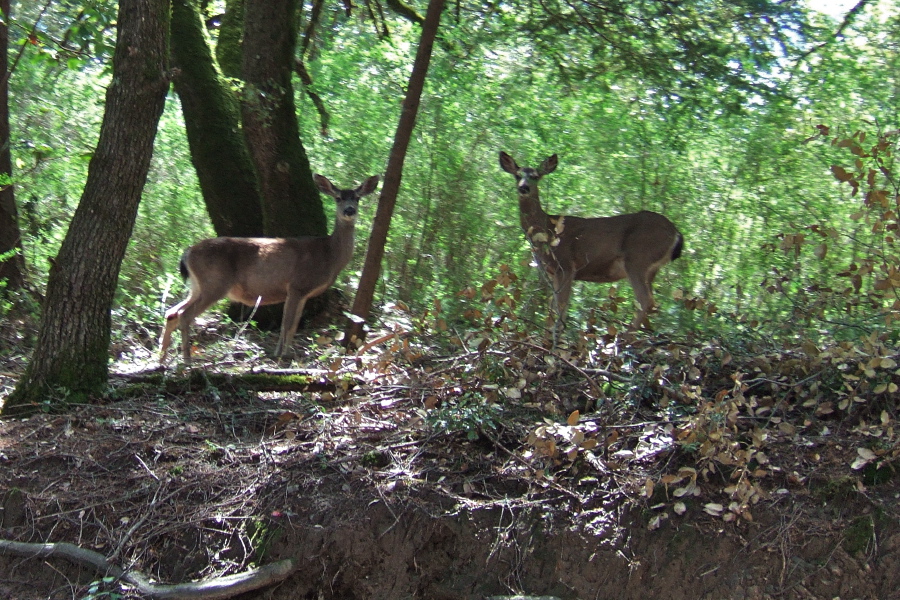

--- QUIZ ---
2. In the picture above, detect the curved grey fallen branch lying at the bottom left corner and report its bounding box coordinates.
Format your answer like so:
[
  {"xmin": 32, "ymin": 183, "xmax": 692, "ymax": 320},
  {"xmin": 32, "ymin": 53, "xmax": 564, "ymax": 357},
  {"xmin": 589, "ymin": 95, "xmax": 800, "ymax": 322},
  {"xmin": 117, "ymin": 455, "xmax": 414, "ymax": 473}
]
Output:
[{"xmin": 0, "ymin": 540, "xmax": 297, "ymax": 600}]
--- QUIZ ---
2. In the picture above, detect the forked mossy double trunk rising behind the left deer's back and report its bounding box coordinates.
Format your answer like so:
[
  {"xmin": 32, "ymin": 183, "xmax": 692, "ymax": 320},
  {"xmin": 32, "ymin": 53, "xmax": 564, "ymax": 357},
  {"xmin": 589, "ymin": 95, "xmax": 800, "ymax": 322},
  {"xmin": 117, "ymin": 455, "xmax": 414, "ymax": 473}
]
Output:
[{"xmin": 172, "ymin": 0, "xmax": 328, "ymax": 237}]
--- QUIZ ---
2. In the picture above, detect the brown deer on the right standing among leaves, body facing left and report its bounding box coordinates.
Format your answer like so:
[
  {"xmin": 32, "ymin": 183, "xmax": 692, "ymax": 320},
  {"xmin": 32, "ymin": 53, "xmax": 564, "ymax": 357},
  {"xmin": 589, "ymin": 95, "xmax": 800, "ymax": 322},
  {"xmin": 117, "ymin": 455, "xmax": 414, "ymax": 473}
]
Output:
[{"xmin": 500, "ymin": 152, "xmax": 684, "ymax": 334}]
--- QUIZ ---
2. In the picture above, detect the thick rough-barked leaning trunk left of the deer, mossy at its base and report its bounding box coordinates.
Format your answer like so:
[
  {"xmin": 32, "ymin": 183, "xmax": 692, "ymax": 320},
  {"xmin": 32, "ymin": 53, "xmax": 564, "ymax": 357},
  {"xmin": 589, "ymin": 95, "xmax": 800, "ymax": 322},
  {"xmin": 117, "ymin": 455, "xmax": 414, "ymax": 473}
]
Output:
[{"xmin": 3, "ymin": 0, "xmax": 170, "ymax": 416}]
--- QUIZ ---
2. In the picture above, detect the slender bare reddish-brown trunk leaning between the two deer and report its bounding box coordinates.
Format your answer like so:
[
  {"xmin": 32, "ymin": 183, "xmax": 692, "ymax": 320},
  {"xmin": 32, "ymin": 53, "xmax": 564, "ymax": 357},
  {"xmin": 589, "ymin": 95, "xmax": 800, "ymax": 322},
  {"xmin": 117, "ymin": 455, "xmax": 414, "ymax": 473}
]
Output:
[{"xmin": 344, "ymin": 0, "xmax": 444, "ymax": 345}]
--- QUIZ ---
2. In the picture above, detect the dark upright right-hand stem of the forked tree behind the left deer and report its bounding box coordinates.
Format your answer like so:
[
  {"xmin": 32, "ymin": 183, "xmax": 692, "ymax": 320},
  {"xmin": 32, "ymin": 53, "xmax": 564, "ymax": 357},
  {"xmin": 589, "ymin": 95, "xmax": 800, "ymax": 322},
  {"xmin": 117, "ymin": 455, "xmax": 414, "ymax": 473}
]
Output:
[{"xmin": 241, "ymin": 0, "xmax": 333, "ymax": 237}]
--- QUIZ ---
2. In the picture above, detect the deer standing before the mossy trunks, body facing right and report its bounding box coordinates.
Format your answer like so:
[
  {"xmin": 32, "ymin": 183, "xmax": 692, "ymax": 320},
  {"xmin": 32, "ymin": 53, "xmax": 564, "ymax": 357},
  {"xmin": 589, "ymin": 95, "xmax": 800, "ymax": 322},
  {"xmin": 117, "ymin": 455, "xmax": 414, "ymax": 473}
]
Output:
[{"xmin": 159, "ymin": 174, "xmax": 378, "ymax": 364}]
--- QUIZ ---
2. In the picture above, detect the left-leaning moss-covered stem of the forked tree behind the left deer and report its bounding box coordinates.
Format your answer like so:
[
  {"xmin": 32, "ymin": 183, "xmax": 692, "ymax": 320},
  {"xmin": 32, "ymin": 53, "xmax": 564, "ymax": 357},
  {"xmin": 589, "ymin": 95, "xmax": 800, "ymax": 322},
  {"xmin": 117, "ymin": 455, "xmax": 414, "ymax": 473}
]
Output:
[{"xmin": 172, "ymin": 0, "xmax": 263, "ymax": 236}]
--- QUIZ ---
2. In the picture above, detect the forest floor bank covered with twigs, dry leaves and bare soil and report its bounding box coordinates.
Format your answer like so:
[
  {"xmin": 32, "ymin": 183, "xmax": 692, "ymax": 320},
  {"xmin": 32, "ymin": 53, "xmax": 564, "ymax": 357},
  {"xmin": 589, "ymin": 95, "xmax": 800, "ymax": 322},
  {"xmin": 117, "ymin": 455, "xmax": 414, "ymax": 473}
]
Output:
[{"xmin": 0, "ymin": 308, "xmax": 900, "ymax": 600}]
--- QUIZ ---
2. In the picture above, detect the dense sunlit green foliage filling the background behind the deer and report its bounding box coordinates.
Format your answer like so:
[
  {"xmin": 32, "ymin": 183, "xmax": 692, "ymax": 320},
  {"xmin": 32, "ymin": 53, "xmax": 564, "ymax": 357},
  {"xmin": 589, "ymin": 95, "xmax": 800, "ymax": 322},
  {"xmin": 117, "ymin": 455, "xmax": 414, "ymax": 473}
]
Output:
[{"xmin": 11, "ymin": 0, "xmax": 900, "ymax": 344}]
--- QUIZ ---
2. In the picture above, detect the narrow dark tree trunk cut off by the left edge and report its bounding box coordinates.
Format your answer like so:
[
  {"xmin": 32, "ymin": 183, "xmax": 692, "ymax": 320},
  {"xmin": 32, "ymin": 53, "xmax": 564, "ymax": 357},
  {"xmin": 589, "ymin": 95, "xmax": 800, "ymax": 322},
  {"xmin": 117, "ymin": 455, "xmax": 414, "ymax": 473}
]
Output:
[{"xmin": 0, "ymin": 0, "xmax": 25, "ymax": 290}]
